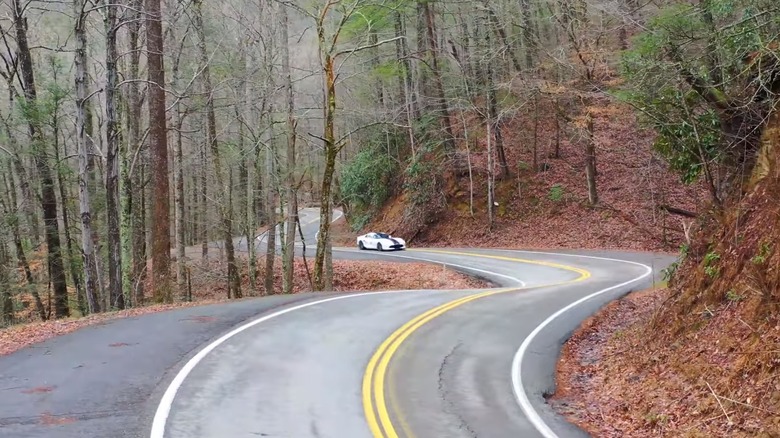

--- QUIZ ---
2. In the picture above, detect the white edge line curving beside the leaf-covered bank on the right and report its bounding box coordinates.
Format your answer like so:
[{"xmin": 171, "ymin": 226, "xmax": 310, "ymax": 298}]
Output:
[{"xmin": 511, "ymin": 251, "xmax": 653, "ymax": 438}]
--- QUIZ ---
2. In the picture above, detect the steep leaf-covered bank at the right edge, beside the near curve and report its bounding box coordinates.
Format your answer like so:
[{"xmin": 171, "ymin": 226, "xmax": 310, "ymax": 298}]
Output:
[{"xmin": 556, "ymin": 113, "xmax": 780, "ymax": 438}]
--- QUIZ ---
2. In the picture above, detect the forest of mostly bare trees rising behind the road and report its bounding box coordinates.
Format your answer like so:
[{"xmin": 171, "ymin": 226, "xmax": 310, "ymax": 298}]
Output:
[{"xmin": 0, "ymin": 0, "xmax": 780, "ymax": 336}]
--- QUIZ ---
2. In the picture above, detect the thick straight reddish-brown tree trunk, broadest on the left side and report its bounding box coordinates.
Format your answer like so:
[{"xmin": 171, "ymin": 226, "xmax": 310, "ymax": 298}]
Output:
[{"xmin": 146, "ymin": 0, "xmax": 173, "ymax": 303}]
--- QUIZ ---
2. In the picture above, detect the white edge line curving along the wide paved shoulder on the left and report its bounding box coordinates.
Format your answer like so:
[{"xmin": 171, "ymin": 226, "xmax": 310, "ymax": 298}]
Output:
[{"xmin": 150, "ymin": 290, "xmax": 424, "ymax": 438}]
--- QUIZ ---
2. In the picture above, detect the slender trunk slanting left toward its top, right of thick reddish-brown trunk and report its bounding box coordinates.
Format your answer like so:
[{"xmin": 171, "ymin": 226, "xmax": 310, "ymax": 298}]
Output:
[{"xmin": 193, "ymin": 0, "xmax": 242, "ymax": 298}]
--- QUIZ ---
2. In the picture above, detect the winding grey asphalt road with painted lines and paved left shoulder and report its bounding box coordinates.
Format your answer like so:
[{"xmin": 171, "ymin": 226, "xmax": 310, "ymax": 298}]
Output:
[{"xmin": 0, "ymin": 209, "xmax": 673, "ymax": 438}]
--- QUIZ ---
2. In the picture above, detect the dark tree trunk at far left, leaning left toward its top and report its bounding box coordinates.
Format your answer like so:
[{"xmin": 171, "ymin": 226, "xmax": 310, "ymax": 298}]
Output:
[{"xmin": 13, "ymin": 0, "xmax": 70, "ymax": 318}]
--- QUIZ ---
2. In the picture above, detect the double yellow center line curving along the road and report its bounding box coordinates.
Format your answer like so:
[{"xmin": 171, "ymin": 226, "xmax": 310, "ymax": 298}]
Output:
[{"xmin": 362, "ymin": 251, "xmax": 591, "ymax": 438}]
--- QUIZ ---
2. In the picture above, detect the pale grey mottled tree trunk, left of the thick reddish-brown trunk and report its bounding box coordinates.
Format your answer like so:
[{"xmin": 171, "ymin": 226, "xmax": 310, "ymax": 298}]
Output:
[{"xmin": 75, "ymin": 0, "xmax": 101, "ymax": 313}]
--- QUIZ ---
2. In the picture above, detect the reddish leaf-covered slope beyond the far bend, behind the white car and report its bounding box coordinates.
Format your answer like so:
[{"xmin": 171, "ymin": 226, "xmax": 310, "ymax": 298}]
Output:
[{"xmin": 362, "ymin": 99, "xmax": 706, "ymax": 251}]
